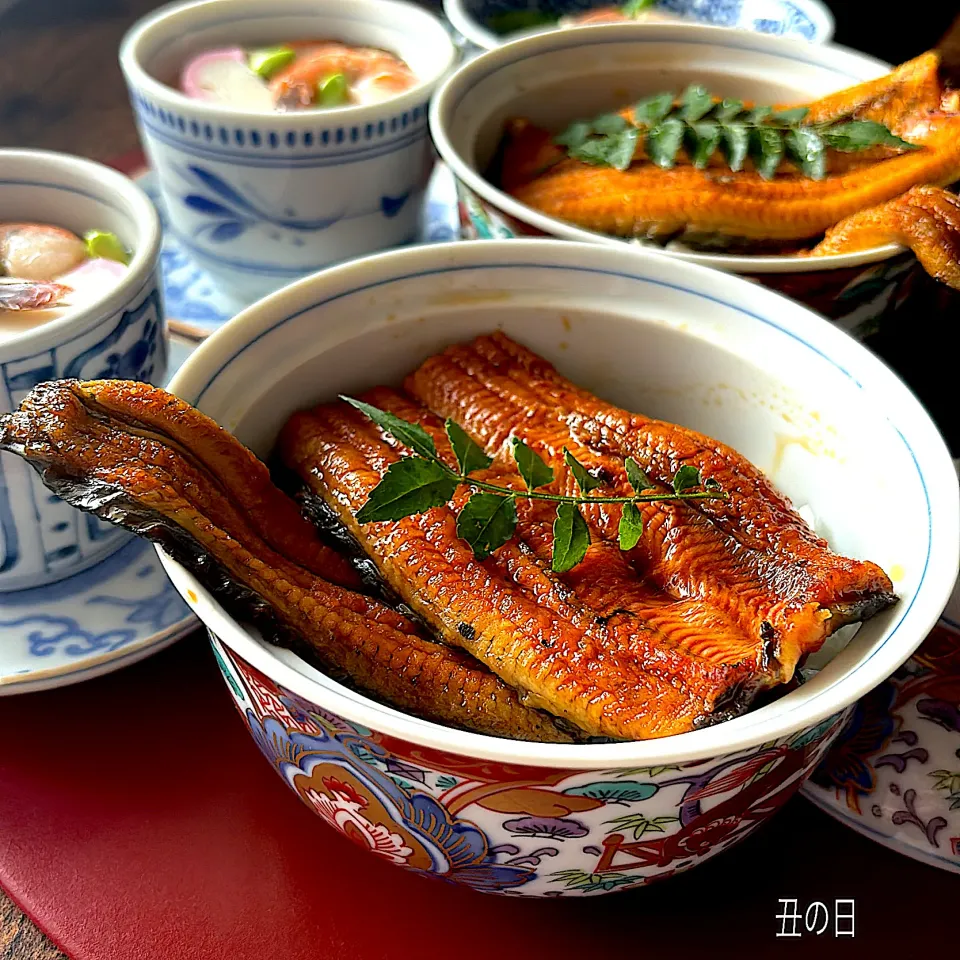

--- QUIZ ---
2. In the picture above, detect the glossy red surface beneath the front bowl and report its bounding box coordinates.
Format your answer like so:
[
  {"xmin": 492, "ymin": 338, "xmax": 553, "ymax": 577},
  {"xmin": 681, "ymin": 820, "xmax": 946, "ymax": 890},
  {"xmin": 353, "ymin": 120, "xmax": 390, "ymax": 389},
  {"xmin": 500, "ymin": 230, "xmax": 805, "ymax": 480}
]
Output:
[{"xmin": 0, "ymin": 634, "xmax": 960, "ymax": 960}]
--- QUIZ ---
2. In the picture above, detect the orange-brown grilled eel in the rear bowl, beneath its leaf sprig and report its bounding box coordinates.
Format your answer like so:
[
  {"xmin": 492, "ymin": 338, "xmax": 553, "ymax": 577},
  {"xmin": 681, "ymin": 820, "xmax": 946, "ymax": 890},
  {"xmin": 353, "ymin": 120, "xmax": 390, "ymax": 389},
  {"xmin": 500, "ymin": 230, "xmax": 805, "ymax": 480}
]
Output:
[{"xmin": 500, "ymin": 53, "xmax": 960, "ymax": 285}]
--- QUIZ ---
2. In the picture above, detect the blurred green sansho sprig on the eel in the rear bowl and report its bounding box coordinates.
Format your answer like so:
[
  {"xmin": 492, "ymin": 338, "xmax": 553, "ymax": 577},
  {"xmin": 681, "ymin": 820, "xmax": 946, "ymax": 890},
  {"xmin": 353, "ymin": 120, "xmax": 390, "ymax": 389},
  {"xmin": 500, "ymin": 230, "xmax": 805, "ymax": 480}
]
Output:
[{"xmin": 554, "ymin": 84, "xmax": 916, "ymax": 180}]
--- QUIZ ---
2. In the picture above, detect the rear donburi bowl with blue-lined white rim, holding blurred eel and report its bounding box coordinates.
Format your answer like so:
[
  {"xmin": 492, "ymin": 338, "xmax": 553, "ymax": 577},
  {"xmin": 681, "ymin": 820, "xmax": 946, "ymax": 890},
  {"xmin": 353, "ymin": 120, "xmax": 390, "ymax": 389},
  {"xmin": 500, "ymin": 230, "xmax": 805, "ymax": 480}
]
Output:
[{"xmin": 430, "ymin": 24, "xmax": 952, "ymax": 337}]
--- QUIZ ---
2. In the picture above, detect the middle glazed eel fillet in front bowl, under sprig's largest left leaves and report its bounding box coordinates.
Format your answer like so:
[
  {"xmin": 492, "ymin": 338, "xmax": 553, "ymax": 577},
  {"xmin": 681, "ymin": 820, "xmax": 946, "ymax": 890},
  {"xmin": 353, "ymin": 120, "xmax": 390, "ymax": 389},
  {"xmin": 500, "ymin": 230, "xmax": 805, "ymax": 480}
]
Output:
[{"xmin": 278, "ymin": 388, "xmax": 753, "ymax": 739}]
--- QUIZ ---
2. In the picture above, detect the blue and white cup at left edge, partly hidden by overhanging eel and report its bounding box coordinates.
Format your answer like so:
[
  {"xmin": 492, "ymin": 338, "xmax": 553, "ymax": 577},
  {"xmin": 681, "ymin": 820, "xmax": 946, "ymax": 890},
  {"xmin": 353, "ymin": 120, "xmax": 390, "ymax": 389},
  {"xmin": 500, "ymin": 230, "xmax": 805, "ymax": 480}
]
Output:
[{"xmin": 0, "ymin": 150, "xmax": 167, "ymax": 592}]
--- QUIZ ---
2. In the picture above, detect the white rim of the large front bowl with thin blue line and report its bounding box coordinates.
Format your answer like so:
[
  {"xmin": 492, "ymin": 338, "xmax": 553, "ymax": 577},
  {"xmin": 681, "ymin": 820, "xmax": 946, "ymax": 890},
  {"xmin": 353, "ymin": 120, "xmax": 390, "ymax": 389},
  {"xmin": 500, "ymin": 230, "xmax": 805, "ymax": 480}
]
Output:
[{"xmin": 161, "ymin": 240, "xmax": 960, "ymax": 769}]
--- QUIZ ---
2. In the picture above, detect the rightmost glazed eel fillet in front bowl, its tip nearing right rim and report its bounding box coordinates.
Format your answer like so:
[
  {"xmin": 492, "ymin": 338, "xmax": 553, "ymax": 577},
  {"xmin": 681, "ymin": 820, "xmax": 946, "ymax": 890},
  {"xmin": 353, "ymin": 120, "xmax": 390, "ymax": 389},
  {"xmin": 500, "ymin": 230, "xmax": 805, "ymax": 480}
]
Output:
[{"xmin": 405, "ymin": 333, "xmax": 896, "ymax": 686}]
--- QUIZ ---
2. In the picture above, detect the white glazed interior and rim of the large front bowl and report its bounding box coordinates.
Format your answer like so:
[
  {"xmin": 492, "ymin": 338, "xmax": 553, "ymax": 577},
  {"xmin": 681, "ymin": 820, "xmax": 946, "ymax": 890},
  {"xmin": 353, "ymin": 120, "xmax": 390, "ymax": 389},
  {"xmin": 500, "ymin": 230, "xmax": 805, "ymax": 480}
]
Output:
[{"xmin": 167, "ymin": 240, "xmax": 960, "ymax": 768}]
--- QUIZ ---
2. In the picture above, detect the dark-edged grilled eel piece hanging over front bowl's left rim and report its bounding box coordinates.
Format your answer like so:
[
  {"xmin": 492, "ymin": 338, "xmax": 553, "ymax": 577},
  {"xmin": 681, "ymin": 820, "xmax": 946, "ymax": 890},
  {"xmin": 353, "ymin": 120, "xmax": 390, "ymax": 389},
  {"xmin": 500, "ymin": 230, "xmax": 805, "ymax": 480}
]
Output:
[{"xmin": 0, "ymin": 380, "xmax": 573, "ymax": 743}]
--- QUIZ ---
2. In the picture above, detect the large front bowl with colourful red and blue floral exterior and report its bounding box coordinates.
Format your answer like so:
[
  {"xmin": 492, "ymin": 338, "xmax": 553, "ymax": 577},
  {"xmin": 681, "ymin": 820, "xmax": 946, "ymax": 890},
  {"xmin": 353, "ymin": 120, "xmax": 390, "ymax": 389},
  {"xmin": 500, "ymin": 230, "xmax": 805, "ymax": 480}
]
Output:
[{"xmin": 165, "ymin": 240, "xmax": 960, "ymax": 896}]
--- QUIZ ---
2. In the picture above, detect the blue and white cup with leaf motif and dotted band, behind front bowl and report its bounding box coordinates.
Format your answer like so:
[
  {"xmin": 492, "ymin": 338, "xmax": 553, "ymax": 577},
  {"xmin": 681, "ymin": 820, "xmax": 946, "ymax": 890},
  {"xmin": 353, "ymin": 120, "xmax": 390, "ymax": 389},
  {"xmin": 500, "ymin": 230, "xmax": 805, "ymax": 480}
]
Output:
[{"xmin": 120, "ymin": 0, "xmax": 455, "ymax": 306}]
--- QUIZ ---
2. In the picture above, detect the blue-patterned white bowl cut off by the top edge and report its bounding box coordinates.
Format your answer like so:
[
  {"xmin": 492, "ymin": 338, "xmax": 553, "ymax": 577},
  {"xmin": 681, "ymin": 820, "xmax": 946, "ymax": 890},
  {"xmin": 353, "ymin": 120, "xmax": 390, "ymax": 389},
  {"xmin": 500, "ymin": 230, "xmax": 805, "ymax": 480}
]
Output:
[{"xmin": 443, "ymin": 0, "xmax": 834, "ymax": 50}]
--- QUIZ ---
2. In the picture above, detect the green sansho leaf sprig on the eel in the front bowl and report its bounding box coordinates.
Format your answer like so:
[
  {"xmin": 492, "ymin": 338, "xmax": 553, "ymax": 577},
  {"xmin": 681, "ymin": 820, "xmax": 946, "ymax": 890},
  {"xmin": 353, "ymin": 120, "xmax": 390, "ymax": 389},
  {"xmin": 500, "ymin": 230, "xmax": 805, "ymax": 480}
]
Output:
[{"xmin": 340, "ymin": 397, "xmax": 727, "ymax": 573}]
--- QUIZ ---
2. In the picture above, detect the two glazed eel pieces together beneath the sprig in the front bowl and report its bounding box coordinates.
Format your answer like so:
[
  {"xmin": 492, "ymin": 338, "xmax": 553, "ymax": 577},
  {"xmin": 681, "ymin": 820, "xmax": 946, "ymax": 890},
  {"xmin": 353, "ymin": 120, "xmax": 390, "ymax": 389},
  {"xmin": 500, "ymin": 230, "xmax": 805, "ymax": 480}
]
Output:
[{"xmin": 279, "ymin": 334, "xmax": 896, "ymax": 738}]
